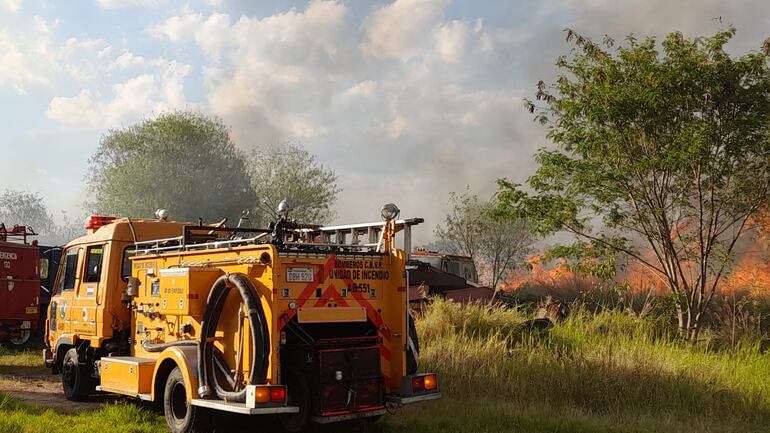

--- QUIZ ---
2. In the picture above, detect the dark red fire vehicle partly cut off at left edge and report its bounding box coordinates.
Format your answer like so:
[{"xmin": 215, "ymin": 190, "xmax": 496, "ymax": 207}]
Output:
[{"xmin": 0, "ymin": 224, "xmax": 59, "ymax": 346}]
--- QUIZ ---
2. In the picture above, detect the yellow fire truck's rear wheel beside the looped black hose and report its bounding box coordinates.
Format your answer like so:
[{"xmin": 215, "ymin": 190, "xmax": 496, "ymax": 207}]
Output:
[{"xmin": 163, "ymin": 367, "xmax": 211, "ymax": 433}]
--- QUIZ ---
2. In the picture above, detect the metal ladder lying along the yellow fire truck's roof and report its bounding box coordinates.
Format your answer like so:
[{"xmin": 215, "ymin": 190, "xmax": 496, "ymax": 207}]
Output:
[{"xmin": 135, "ymin": 218, "xmax": 425, "ymax": 255}]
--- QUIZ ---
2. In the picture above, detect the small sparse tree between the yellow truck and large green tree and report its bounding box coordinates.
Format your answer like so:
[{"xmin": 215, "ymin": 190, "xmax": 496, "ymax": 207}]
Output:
[{"xmin": 434, "ymin": 191, "xmax": 534, "ymax": 292}]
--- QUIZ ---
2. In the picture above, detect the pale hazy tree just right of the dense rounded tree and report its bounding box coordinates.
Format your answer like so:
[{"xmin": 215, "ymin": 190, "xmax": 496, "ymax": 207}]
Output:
[{"xmin": 249, "ymin": 143, "xmax": 341, "ymax": 224}]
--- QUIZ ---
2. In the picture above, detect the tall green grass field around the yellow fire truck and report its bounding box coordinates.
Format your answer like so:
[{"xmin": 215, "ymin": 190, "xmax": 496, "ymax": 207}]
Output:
[{"xmin": 0, "ymin": 302, "xmax": 770, "ymax": 433}]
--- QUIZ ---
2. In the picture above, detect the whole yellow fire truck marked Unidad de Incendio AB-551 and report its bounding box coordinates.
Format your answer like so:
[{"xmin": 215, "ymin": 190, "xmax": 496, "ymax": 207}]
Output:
[{"xmin": 44, "ymin": 204, "xmax": 440, "ymax": 432}]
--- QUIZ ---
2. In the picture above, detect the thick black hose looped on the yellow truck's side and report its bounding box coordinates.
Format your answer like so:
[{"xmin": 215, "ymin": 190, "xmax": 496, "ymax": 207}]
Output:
[{"xmin": 198, "ymin": 274, "xmax": 270, "ymax": 402}]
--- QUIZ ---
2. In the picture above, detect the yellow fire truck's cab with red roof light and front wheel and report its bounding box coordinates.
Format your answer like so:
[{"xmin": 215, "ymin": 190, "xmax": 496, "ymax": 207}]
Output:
[{"xmin": 44, "ymin": 216, "xmax": 189, "ymax": 388}]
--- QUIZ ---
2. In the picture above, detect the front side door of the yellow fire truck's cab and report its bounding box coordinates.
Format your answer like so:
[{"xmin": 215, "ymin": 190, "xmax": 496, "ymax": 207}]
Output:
[{"xmin": 48, "ymin": 247, "xmax": 83, "ymax": 341}]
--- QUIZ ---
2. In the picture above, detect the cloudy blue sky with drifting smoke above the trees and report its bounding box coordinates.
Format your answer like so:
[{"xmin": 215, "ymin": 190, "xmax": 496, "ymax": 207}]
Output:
[{"xmin": 0, "ymin": 0, "xmax": 770, "ymax": 243}]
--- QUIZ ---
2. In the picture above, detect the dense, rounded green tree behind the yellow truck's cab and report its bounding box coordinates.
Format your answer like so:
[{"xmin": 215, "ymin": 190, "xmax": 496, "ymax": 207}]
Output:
[{"xmin": 86, "ymin": 112, "xmax": 256, "ymax": 226}]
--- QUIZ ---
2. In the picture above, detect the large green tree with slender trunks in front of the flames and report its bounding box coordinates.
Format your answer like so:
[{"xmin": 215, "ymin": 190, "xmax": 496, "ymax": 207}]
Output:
[{"xmin": 499, "ymin": 27, "xmax": 770, "ymax": 339}]
